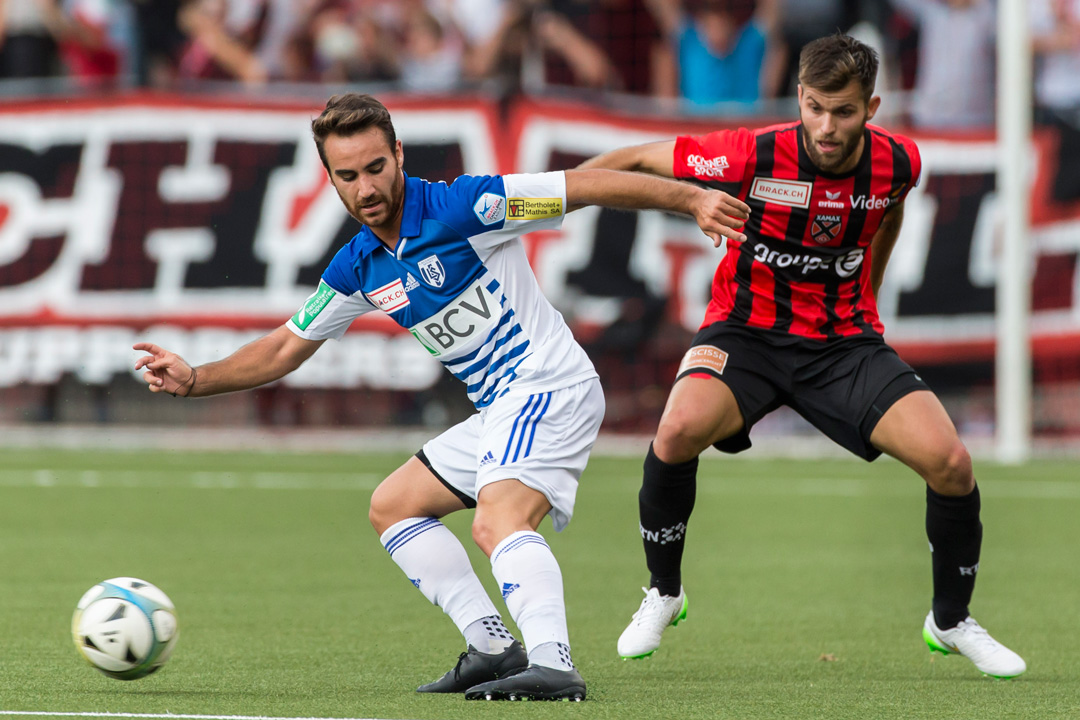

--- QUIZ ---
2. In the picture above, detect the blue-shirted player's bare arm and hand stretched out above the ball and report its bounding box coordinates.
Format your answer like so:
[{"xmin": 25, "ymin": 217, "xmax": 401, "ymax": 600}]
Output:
[{"xmin": 134, "ymin": 325, "xmax": 324, "ymax": 397}]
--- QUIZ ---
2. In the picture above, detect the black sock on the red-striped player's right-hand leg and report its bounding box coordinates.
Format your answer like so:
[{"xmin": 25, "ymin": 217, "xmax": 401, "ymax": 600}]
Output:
[{"xmin": 927, "ymin": 486, "xmax": 983, "ymax": 629}]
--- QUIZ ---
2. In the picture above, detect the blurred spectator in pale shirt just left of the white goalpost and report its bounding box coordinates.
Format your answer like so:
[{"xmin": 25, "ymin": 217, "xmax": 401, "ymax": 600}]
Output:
[{"xmin": 892, "ymin": 0, "xmax": 997, "ymax": 130}]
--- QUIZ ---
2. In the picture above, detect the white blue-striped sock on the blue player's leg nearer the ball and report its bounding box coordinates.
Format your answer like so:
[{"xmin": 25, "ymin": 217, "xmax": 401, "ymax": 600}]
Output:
[{"xmin": 379, "ymin": 517, "xmax": 499, "ymax": 652}]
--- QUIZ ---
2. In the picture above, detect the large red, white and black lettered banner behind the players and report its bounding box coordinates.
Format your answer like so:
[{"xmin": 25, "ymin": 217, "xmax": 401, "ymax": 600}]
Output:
[{"xmin": 0, "ymin": 97, "xmax": 1080, "ymax": 390}]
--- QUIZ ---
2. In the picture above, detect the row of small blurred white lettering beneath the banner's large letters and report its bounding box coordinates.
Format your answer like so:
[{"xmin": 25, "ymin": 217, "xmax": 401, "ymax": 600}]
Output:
[{"xmin": 0, "ymin": 325, "xmax": 443, "ymax": 391}]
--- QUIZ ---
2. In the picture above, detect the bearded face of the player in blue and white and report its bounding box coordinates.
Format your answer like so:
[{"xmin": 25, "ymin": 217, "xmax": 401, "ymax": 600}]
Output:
[{"xmin": 323, "ymin": 127, "xmax": 405, "ymax": 230}]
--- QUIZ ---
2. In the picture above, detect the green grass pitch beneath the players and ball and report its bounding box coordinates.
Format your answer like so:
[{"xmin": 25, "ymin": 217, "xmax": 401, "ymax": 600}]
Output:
[{"xmin": 0, "ymin": 448, "xmax": 1080, "ymax": 720}]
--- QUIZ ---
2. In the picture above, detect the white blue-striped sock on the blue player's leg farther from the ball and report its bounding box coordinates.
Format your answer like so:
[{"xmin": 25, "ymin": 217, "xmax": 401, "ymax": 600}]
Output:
[{"xmin": 491, "ymin": 531, "xmax": 573, "ymax": 670}]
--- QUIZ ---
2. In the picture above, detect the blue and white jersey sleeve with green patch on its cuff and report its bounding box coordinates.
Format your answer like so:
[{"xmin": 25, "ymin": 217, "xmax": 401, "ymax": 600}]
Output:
[{"xmin": 285, "ymin": 245, "xmax": 376, "ymax": 340}]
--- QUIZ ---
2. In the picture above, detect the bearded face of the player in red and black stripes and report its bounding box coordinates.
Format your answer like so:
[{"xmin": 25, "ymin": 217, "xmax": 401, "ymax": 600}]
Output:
[{"xmin": 799, "ymin": 80, "xmax": 880, "ymax": 173}]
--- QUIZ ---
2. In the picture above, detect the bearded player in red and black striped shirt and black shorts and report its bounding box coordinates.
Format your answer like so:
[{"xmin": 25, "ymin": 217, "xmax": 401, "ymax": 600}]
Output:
[{"xmin": 582, "ymin": 35, "xmax": 1026, "ymax": 678}]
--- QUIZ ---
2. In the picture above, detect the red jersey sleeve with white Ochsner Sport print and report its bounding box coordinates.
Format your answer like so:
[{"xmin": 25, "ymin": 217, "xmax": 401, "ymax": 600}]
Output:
[{"xmin": 672, "ymin": 128, "xmax": 757, "ymax": 194}]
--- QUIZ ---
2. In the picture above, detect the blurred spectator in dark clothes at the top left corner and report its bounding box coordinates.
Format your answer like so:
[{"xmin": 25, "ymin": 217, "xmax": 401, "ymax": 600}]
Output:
[{"xmin": 0, "ymin": 0, "xmax": 58, "ymax": 78}]
